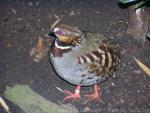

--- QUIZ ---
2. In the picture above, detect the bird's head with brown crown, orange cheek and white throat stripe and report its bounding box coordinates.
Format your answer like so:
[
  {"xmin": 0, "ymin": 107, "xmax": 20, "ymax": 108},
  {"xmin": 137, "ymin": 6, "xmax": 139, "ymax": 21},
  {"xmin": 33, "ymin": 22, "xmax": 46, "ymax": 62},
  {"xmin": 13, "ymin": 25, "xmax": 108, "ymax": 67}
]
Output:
[{"xmin": 53, "ymin": 25, "xmax": 83, "ymax": 49}]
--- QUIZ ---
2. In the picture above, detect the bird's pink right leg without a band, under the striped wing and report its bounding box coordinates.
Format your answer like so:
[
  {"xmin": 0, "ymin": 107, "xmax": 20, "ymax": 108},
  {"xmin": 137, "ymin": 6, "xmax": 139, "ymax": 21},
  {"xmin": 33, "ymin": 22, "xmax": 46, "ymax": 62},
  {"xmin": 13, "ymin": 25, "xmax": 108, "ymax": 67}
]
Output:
[{"xmin": 84, "ymin": 84, "xmax": 101, "ymax": 103}]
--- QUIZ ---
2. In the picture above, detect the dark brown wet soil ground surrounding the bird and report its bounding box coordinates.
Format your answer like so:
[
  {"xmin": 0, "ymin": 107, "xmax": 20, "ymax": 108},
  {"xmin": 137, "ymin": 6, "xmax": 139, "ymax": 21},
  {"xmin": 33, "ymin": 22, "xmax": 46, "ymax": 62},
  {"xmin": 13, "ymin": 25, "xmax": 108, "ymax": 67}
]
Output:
[{"xmin": 0, "ymin": 0, "xmax": 150, "ymax": 113}]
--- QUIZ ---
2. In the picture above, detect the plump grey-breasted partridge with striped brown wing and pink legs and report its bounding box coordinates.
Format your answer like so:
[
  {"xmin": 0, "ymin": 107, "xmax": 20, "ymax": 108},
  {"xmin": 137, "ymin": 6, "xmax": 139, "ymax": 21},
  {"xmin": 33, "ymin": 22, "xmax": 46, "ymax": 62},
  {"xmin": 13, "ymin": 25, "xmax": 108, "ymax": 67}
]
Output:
[{"xmin": 49, "ymin": 24, "xmax": 120, "ymax": 102}]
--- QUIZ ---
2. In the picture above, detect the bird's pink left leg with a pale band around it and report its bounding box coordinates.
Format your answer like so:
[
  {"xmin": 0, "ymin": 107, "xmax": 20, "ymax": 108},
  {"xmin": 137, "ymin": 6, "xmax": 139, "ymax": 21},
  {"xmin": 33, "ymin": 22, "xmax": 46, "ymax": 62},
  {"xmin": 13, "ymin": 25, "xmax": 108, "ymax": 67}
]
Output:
[{"xmin": 63, "ymin": 86, "xmax": 80, "ymax": 101}]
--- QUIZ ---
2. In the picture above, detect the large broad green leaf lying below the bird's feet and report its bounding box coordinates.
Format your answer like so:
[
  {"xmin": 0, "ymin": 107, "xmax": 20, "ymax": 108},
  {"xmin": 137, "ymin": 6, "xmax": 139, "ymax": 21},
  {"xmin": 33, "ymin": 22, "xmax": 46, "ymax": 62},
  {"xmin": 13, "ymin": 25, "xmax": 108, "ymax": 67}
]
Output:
[{"xmin": 4, "ymin": 84, "xmax": 78, "ymax": 113}]
